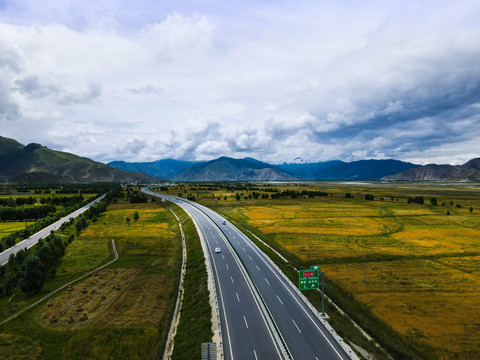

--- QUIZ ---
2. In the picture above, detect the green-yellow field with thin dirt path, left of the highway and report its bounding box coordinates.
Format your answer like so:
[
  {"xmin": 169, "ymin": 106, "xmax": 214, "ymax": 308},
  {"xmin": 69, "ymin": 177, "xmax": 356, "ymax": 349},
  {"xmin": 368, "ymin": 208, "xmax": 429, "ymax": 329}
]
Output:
[{"xmin": 0, "ymin": 198, "xmax": 181, "ymax": 359}]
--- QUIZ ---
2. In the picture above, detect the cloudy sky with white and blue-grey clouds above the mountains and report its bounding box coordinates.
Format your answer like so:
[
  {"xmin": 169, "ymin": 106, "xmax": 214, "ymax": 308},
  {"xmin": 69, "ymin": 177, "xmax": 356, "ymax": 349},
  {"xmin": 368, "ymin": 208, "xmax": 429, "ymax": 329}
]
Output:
[{"xmin": 0, "ymin": 0, "xmax": 480, "ymax": 164}]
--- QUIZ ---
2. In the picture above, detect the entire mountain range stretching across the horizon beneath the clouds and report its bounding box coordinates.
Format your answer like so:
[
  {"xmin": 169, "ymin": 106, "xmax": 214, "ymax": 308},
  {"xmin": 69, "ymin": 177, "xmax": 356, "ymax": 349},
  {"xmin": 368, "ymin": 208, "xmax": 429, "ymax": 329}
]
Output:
[{"xmin": 0, "ymin": 136, "xmax": 480, "ymax": 184}]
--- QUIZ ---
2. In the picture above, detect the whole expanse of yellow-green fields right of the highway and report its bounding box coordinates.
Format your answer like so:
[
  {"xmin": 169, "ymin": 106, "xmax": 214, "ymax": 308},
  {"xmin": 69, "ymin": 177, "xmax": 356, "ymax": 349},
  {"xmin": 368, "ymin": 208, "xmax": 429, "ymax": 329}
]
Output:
[{"xmin": 162, "ymin": 184, "xmax": 480, "ymax": 359}]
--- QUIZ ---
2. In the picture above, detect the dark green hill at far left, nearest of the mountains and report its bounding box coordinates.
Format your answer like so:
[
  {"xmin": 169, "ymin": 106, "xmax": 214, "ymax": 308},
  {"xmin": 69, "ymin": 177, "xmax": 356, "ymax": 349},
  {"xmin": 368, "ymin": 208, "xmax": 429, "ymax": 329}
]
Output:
[{"xmin": 0, "ymin": 136, "xmax": 155, "ymax": 184}]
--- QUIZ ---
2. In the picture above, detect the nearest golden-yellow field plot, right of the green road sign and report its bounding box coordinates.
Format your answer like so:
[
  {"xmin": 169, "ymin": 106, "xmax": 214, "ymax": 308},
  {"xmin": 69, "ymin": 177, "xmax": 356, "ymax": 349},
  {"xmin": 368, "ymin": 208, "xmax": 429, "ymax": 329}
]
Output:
[{"xmin": 322, "ymin": 260, "xmax": 480, "ymax": 352}]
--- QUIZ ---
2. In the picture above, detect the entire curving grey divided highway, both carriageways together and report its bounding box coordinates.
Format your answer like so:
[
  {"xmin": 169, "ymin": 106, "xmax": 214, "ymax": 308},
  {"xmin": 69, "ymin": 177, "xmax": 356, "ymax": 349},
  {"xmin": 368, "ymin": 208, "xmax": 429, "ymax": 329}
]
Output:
[{"xmin": 142, "ymin": 189, "xmax": 356, "ymax": 360}]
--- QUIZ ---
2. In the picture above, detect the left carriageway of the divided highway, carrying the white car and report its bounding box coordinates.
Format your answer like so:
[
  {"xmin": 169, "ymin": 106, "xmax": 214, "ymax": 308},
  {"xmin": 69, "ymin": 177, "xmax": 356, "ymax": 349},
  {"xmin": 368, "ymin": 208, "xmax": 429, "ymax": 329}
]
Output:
[{"xmin": 144, "ymin": 191, "xmax": 285, "ymax": 360}]
